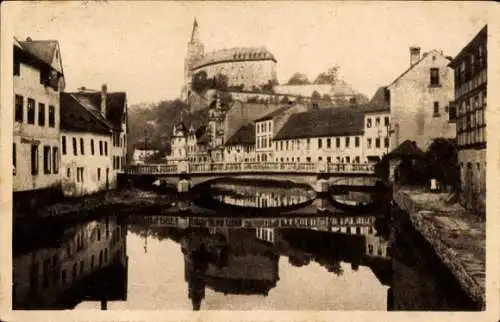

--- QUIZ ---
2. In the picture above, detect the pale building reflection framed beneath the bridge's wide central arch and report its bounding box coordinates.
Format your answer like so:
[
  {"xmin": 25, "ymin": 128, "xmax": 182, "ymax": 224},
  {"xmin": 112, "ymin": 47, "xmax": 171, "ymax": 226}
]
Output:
[{"xmin": 211, "ymin": 183, "xmax": 315, "ymax": 208}]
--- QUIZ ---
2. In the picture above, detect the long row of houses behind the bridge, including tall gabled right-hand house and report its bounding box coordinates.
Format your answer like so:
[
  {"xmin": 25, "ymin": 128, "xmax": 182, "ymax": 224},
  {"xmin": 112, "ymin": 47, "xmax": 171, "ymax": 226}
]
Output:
[{"xmin": 167, "ymin": 43, "xmax": 455, "ymax": 163}]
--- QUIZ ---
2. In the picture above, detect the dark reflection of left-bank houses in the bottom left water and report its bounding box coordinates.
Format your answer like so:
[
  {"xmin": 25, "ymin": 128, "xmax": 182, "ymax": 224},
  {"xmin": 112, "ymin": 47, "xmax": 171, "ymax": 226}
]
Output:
[{"xmin": 12, "ymin": 216, "xmax": 128, "ymax": 309}]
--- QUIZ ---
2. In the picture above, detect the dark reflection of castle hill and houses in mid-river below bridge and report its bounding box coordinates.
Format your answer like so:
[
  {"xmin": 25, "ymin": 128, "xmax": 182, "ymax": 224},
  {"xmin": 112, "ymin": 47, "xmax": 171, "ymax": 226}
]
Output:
[{"xmin": 135, "ymin": 216, "xmax": 392, "ymax": 310}]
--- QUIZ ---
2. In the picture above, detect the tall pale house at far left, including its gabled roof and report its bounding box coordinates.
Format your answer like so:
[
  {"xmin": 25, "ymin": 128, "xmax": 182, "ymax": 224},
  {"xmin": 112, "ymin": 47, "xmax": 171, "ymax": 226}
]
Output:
[{"xmin": 12, "ymin": 38, "xmax": 65, "ymax": 203}]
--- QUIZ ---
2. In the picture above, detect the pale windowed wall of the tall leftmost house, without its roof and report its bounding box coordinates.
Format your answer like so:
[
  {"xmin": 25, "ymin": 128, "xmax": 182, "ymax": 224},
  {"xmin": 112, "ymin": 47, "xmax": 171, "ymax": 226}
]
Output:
[{"xmin": 11, "ymin": 52, "xmax": 62, "ymax": 192}]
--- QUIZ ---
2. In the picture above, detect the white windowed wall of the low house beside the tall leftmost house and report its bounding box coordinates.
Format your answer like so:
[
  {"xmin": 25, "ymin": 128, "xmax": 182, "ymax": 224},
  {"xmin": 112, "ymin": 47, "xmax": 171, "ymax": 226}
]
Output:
[{"xmin": 61, "ymin": 131, "xmax": 112, "ymax": 196}]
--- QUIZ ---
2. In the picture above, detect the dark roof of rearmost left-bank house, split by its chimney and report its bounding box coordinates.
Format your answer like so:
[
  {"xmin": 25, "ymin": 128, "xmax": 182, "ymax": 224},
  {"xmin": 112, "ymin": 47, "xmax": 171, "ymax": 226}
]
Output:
[{"xmin": 72, "ymin": 91, "xmax": 127, "ymax": 130}]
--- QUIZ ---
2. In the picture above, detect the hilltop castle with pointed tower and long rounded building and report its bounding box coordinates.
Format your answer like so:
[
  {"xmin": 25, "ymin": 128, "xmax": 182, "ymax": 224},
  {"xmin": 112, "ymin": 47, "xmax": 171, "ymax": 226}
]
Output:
[{"xmin": 182, "ymin": 19, "xmax": 277, "ymax": 100}]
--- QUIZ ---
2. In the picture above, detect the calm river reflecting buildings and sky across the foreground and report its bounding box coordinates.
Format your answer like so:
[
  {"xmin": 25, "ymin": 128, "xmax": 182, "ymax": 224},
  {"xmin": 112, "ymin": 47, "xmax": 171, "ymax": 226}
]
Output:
[{"xmin": 13, "ymin": 183, "xmax": 476, "ymax": 311}]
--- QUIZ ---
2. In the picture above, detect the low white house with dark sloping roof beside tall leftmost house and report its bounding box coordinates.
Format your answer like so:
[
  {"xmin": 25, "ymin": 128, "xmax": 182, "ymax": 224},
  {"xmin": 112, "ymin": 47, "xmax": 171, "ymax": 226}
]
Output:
[{"xmin": 61, "ymin": 93, "xmax": 113, "ymax": 196}]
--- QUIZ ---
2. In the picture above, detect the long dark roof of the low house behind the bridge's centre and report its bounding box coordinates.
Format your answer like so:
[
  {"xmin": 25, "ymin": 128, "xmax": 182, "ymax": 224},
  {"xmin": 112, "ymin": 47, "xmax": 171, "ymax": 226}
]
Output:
[{"xmin": 274, "ymin": 107, "xmax": 364, "ymax": 140}]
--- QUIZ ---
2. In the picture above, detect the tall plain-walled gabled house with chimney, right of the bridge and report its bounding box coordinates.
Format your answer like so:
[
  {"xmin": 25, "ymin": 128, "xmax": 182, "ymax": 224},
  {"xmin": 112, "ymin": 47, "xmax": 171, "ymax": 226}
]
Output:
[{"xmin": 387, "ymin": 47, "xmax": 456, "ymax": 151}]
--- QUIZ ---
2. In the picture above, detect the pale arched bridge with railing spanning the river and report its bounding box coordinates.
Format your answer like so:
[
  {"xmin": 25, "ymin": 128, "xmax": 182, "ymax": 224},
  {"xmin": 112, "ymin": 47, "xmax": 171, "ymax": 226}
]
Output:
[{"xmin": 120, "ymin": 162, "xmax": 379, "ymax": 191}]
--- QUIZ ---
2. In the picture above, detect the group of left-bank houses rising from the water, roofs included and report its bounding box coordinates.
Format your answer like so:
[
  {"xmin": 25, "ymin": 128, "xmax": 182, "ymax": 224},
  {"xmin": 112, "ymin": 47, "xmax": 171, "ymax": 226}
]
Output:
[{"xmin": 12, "ymin": 38, "xmax": 127, "ymax": 214}]
